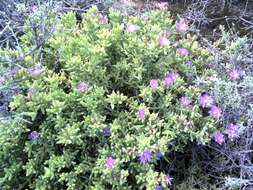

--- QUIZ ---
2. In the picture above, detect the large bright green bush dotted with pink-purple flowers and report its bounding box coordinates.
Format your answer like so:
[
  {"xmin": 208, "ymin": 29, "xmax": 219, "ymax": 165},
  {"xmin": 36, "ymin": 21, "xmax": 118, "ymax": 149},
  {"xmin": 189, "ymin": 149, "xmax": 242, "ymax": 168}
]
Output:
[{"xmin": 0, "ymin": 8, "xmax": 220, "ymax": 190}]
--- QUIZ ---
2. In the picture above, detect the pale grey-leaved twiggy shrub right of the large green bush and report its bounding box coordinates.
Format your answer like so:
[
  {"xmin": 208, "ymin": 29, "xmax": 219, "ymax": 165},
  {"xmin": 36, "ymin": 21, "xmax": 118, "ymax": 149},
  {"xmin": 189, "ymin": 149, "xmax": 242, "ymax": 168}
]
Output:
[{"xmin": 194, "ymin": 27, "xmax": 253, "ymax": 189}]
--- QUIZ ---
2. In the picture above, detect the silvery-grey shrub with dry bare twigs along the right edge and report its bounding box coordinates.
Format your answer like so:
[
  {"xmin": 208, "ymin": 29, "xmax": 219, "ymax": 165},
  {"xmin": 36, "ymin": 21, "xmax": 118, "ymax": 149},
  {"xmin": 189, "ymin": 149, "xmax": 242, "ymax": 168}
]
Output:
[{"xmin": 170, "ymin": 27, "xmax": 253, "ymax": 190}]
